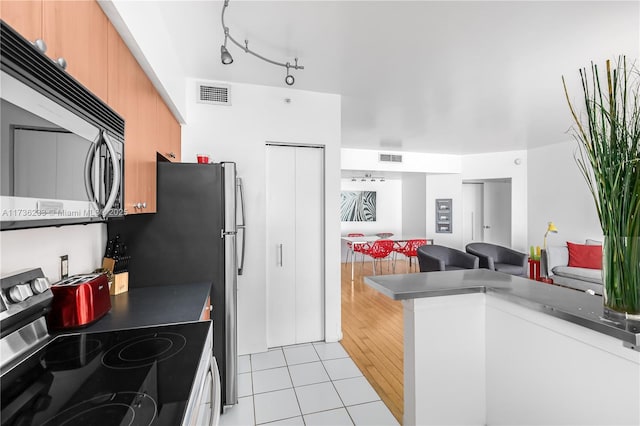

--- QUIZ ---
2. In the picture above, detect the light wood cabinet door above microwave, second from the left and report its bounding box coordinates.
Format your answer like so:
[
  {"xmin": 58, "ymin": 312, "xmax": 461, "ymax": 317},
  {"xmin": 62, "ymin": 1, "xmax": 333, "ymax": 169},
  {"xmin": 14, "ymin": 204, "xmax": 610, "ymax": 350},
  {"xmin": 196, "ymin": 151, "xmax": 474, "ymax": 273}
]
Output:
[{"xmin": 42, "ymin": 0, "xmax": 109, "ymax": 101}]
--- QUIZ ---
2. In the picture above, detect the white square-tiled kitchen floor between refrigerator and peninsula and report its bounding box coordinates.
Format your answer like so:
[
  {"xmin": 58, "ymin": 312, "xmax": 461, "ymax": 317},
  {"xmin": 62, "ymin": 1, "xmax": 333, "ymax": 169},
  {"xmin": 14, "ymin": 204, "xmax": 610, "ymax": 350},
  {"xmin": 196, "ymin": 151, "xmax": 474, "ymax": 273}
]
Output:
[{"xmin": 220, "ymin": 342, "xmax": 398, "ymax": 426}]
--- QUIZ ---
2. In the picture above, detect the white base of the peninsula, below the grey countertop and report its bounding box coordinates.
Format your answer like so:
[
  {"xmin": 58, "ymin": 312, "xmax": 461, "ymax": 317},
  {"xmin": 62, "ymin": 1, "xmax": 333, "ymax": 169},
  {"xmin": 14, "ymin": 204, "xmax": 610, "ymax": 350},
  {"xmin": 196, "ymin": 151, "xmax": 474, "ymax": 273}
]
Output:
[{"xmin": 403, "ymin": 293, "xmax": 640, "ymax": 426}]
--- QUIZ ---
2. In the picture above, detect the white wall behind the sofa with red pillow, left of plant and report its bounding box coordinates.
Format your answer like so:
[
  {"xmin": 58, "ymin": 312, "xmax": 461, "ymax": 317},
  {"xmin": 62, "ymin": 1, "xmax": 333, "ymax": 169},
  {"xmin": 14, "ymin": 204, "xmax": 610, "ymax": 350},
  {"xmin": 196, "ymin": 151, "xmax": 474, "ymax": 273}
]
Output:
[{"xmin": 528, "ymin": 140, "xmax": 602, "ymax": 247}]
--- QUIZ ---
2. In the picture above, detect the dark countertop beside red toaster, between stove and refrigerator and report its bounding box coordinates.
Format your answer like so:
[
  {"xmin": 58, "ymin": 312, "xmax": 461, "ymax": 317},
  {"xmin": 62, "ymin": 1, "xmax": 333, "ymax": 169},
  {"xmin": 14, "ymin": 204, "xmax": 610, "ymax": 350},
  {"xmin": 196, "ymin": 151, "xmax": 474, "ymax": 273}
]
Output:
[{"xmin": 78, "ymin": 283, "xmax": 211, "ymax": 333}]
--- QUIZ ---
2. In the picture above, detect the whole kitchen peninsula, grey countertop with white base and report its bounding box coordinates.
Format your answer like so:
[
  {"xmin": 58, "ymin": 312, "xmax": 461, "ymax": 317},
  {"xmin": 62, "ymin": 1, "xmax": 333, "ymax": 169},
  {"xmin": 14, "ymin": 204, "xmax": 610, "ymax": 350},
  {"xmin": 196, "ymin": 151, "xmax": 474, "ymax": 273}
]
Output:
[{"xmin": 365, "ymin": 269, "xmax": 640, "ymax": 425}]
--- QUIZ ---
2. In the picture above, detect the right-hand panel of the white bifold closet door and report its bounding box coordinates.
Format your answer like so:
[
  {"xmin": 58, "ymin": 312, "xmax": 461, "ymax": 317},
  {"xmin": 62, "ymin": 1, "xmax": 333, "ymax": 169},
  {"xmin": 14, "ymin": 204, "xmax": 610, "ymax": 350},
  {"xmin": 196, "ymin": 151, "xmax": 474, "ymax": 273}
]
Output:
[{"xmin": 295, "ymin": 148, "xmax": 324, "ymax": 343}]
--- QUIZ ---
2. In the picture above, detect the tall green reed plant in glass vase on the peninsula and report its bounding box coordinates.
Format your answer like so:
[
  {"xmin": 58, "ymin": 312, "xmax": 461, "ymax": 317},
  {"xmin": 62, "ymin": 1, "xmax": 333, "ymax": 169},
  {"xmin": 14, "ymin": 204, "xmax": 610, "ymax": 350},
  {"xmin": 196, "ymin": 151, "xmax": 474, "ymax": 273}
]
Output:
[{"xmin": 562, "ymin": 57, "xmax": 640, "ymax": 315}]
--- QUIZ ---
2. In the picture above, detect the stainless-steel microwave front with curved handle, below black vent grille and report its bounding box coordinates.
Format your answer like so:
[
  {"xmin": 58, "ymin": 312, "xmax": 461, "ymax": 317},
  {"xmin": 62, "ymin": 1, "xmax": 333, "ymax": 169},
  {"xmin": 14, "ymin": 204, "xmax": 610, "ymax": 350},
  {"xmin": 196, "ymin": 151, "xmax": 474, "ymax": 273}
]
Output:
[{"xmin": 0, "ymin": 71, "xmax": 122, "ymax": 229}]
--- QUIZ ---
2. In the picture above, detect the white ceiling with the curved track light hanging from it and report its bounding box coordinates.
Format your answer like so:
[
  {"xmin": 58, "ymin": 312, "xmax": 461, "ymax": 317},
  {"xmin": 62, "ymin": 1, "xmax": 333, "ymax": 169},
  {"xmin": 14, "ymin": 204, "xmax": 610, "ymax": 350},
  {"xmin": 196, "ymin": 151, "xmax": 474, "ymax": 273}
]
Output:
[{"xmin": 149, "ymin": 0, "xmax": 640, "ymax": 154}]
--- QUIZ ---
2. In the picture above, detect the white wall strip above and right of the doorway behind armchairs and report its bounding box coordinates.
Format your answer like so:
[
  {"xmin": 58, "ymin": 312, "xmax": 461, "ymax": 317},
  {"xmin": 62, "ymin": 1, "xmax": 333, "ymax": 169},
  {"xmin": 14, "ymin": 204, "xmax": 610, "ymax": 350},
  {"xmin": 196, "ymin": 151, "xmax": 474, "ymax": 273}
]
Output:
[{"xmin": 462, "ymin": 151, "xmax": 535, "ymax": 251}]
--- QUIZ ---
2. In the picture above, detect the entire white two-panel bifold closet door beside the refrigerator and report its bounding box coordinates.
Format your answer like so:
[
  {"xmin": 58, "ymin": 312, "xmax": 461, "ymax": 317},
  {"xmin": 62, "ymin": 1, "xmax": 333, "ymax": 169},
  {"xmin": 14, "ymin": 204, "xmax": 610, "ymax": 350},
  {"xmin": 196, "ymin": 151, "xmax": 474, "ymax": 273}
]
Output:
[{"xmin": 266, "ymin": 146, "xmax": 324, "ymax": 347}]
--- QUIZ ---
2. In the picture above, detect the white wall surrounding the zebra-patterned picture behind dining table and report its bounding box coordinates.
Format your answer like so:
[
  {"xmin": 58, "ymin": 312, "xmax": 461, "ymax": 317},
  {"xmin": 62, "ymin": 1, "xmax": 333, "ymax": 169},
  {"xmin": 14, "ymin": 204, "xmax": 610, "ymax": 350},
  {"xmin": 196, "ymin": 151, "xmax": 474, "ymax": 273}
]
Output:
[{"xmin": 340, "ymin": 179, "xmax": 402, "ymax": 261}]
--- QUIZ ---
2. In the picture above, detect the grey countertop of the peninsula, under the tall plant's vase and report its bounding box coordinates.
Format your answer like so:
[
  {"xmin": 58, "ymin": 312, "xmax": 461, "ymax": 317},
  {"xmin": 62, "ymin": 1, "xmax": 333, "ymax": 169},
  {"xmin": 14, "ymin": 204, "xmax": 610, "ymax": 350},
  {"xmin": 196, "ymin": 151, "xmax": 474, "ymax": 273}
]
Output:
[{"xmin": 364, "ymin": 269, "xmax": 640, "ymax": 348}]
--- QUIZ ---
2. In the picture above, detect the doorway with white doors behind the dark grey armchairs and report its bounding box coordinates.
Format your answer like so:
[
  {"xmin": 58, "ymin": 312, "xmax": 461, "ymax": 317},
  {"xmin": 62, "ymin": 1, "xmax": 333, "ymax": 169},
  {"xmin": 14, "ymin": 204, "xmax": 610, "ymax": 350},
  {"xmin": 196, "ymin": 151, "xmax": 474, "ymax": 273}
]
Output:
[{"xmin": 462, "ymin": 178, "xmax": 511, "ymax": 247}]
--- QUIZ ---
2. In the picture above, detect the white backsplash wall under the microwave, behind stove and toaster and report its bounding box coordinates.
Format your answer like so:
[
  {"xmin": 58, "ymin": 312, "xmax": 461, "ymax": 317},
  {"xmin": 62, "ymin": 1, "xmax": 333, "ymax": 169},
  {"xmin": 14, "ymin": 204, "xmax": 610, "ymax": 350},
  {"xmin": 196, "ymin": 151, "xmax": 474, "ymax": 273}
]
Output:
[{"xmin": 0, "ymin": 223, "xmax": 107, "ymax": 283}]
